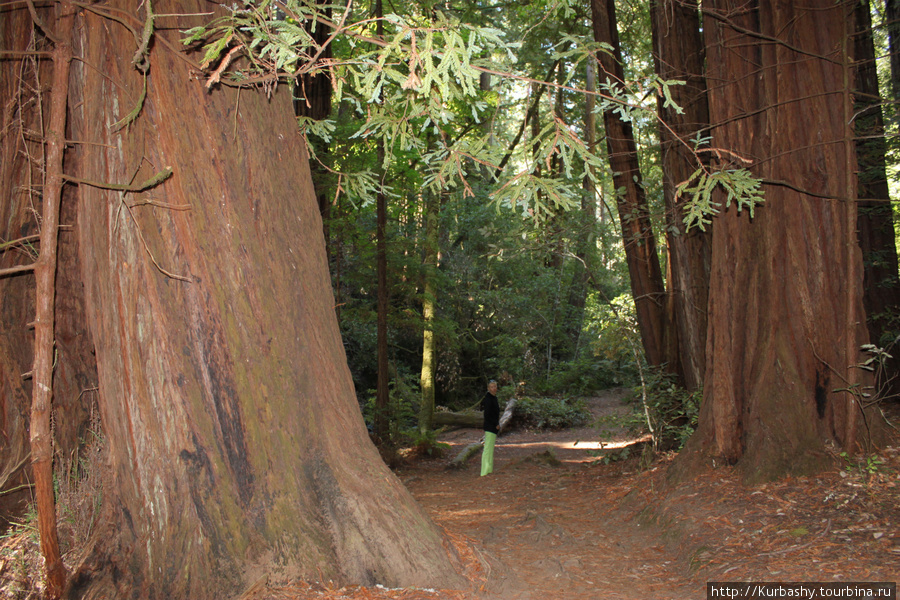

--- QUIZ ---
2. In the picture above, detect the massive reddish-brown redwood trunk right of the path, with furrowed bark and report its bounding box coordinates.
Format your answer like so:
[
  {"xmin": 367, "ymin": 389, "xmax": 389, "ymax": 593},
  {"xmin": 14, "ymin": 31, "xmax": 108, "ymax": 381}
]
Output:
[{"xmin": 677, "ymin": 0, "xmax": 878, "ymax": 481}]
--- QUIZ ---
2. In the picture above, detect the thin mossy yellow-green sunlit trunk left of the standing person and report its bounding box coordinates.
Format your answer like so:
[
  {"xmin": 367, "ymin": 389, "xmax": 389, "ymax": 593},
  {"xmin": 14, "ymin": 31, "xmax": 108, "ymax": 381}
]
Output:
[{"xmin": 419, "ymin": 191, "xmax": 440, "ymax": 434}]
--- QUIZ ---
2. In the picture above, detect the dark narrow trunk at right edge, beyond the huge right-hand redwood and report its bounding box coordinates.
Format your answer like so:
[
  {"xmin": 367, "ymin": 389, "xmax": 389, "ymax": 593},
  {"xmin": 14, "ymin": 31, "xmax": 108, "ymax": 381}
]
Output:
[{"xmin": 854, "ymin": 0, "xmax": 900, "ymax": 396}]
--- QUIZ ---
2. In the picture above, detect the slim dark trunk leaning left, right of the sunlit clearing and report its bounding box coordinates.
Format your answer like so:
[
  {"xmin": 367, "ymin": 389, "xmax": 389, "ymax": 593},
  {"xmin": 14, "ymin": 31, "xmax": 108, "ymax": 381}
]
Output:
[{"xmin": 591, "ymin": 0, "xmax": 666, "ymax": 365}]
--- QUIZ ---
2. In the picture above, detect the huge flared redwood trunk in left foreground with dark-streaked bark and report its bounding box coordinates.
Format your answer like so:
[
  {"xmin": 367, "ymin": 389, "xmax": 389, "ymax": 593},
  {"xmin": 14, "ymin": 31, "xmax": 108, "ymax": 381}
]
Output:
[{"xmin": 64, "ymin": 1, "xmax": 460, "ymax": 598}]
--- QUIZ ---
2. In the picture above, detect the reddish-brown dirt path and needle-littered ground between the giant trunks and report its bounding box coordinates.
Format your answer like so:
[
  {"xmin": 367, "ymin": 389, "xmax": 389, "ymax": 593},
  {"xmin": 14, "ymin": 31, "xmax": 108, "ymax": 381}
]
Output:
[{"xmin": 398, "ymin": 390, "xmax": 900, "ymax": 600}]
